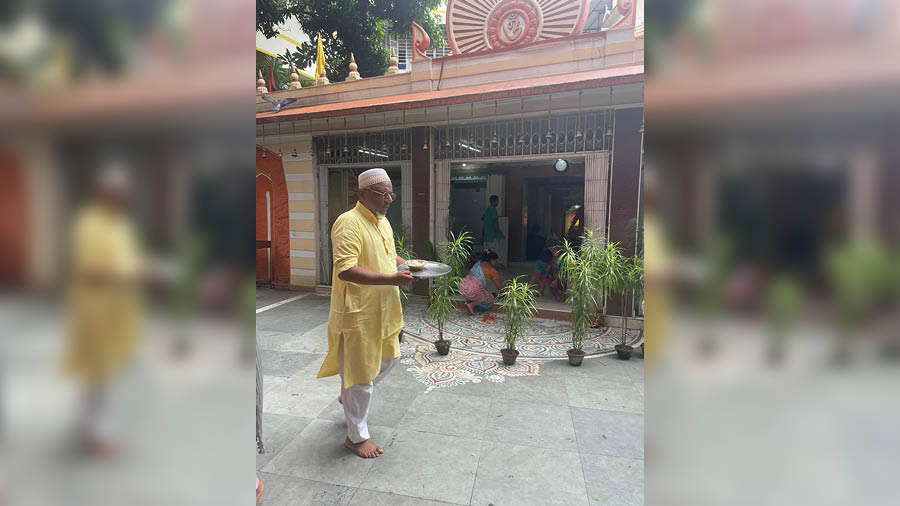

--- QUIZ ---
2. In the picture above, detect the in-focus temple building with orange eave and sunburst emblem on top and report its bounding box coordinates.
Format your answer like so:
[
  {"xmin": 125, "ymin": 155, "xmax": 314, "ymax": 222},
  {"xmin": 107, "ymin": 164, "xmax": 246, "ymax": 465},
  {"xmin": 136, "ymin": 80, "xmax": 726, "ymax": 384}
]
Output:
[{"xmin": 256, "ymin": 0, "xmax": 644, "ymax": 300}]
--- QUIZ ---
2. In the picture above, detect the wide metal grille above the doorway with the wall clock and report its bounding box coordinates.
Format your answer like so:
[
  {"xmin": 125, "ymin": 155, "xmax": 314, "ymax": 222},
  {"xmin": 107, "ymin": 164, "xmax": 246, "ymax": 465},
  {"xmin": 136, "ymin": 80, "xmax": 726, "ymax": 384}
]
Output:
[{"xmin": 434, "ymin": 111, "xmax": 615, "ymax": 160}]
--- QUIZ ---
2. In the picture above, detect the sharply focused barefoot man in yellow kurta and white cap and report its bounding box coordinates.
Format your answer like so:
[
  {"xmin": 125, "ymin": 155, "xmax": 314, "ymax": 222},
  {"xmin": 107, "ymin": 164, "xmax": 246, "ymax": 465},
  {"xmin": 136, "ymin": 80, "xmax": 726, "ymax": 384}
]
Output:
[{"xmin": 319, "ymin": 169, "xmax": 412, "ymax": 458}]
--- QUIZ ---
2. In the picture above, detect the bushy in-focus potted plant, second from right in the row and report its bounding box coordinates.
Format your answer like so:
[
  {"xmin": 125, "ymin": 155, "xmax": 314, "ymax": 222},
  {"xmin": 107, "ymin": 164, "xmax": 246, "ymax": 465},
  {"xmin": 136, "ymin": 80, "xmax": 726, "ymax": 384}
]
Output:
[{"xmin": 559, "ymin": 230, "xmax": 603, "ymax": 366}]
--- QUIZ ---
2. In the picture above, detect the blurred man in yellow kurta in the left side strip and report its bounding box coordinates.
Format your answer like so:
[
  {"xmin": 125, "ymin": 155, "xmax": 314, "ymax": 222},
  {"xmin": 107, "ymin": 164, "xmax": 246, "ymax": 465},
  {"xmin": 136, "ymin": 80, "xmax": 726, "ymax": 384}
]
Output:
[{"xmin": 62, "ymin": 169, "xmax": 142, "ymax": 456}]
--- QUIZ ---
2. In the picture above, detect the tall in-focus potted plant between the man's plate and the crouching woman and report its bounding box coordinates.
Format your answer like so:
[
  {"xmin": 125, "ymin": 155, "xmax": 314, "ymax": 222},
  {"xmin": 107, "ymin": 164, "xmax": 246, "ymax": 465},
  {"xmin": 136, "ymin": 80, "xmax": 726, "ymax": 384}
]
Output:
[{"xmin": 427, "ymin": 231, "xmax": 472, "ymax": 355}]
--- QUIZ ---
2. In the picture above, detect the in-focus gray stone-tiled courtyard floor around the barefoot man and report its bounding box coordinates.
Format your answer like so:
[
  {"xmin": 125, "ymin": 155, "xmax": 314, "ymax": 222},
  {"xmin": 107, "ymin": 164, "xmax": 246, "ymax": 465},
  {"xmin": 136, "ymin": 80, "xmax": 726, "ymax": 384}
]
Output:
[{"xmin": 256, "ymin": 288, "xmax": 644, "ymax": 506}]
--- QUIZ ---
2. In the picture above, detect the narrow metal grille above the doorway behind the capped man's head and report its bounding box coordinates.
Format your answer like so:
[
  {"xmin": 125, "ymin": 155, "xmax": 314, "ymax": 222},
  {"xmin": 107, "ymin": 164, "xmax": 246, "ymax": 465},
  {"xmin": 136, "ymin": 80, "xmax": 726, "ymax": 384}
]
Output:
[{"xmin": 314, "ymin": 129, "xmax": 411, "ymax": 164}]
